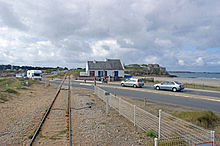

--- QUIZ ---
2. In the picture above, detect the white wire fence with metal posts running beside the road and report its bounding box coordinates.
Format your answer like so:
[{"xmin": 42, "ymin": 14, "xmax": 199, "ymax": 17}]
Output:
[{"xmin": 94, "ymin": 86, "xmax": 215, "ymax": 146}]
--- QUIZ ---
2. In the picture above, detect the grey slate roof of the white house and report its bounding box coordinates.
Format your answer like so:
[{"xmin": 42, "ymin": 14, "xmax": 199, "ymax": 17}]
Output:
[{"xmin": 87, "ymin": 59, "xmax": 124, "ymax": 70}]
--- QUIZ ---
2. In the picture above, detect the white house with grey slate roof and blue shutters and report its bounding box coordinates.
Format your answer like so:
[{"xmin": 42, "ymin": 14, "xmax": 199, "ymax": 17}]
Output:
[{"xmin": 86, "ymin": 59, "xmax": 124, "ymax": 77}]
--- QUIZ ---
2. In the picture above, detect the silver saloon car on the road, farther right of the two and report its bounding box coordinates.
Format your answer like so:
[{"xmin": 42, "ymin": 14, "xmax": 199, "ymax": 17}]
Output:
[{"xmin": 154, "ymin": 81, "xmax": 184, "ymax": 92}]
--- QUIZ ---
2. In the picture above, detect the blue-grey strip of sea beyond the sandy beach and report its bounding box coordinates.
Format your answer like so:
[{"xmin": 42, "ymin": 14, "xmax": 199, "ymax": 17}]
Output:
[{"xmin": 168, "ymin": 72, "xmax": 220, "ymax": 80}]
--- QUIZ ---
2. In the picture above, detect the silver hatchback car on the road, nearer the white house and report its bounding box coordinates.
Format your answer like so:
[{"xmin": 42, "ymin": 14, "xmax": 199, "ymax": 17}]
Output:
[{"xmin": 121, "ymin": 78, "xmax": 144, "ymax": 88}]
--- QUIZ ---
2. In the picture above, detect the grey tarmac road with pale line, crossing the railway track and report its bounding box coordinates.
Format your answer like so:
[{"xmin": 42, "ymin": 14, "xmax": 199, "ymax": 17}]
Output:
[{"xmin": 50, "ymin": 80, "xmax": 220, "ymax": 113}]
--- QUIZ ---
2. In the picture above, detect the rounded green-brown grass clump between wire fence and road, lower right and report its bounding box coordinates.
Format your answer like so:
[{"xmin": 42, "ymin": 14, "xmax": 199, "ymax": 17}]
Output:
[{"xmin": 175, "ymin": 111, "xmax": 220, "ymax": 128}]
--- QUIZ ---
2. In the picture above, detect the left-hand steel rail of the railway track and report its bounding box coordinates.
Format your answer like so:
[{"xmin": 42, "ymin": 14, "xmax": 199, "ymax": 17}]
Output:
[{"xmin": 28, "ymin": 73, "xmax": 67, "ymax": 146}]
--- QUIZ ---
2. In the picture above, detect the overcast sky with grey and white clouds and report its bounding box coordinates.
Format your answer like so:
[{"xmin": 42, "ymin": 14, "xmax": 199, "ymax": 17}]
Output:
[{"xmin": 0, "ymin": 0, "xmax": 220, "ymax": 72}]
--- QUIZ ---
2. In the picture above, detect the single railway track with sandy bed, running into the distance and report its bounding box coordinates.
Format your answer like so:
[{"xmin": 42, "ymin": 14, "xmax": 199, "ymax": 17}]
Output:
[{"xmin": 29, "ymin": 72, "xmax": 72, "ymax": 146}]
